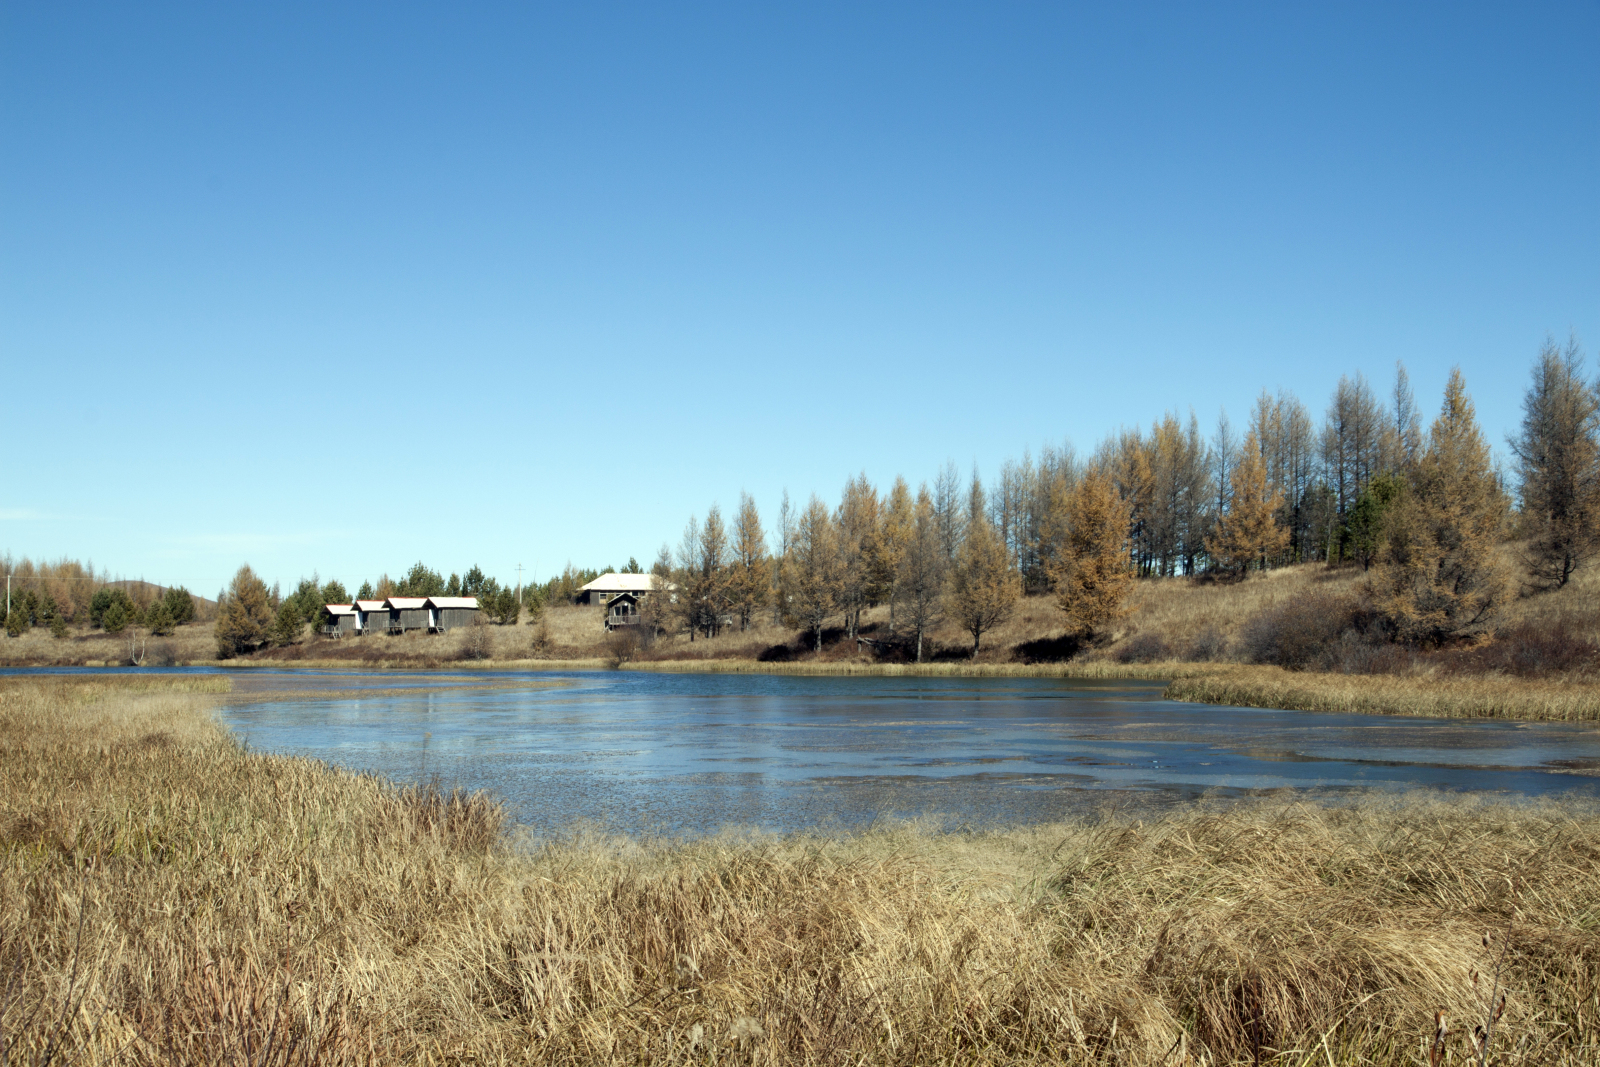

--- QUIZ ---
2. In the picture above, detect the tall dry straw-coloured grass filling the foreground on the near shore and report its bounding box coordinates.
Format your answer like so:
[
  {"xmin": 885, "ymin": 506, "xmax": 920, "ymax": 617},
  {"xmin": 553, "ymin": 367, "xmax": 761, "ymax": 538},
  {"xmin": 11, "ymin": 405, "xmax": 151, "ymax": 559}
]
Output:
[{"xmin": 0, "ymin": 678, "xmax": 1600, "ymax": 1067}]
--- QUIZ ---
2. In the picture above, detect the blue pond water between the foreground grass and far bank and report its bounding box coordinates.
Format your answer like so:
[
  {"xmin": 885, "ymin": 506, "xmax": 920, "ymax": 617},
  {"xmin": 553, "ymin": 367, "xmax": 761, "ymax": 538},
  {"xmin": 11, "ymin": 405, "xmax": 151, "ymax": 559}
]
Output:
[{"xmin": 203, "ymin": 672, "xmax": 1600, "ymax": 835}]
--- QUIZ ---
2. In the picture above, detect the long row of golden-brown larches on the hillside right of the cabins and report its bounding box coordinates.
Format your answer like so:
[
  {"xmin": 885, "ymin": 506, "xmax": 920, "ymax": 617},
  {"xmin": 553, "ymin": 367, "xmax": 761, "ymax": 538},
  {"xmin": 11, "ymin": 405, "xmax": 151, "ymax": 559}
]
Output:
[{"xmin": 650, "ymin": 341, "xmax": 1600, "ymax": 661}]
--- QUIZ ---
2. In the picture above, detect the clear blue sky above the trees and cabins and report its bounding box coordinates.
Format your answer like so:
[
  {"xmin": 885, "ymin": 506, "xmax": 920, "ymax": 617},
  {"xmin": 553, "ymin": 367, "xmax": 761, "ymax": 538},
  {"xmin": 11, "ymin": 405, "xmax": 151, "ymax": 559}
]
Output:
[{"xmin": 0, "ymin": 3, "xmax": 1600, "ymax": 595}]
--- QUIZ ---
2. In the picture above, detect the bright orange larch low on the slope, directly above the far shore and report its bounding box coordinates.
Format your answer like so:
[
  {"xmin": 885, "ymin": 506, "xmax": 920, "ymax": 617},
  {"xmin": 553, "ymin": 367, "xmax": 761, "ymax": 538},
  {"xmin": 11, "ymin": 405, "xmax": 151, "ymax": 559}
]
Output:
[{"xmin": 1050, "ymin": 470, "xmax": 1133, "ymax": 637}]
